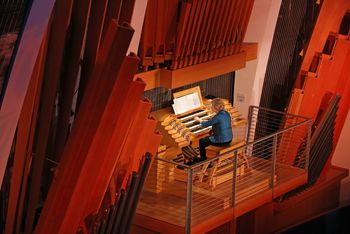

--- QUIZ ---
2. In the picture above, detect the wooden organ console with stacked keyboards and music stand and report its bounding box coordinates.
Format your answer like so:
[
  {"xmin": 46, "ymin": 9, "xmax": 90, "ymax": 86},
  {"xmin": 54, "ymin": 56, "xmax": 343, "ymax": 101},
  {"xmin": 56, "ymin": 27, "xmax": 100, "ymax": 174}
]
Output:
[{"xmin": 152, "ymin": 86, "xmax": 245, "ymax": 159}]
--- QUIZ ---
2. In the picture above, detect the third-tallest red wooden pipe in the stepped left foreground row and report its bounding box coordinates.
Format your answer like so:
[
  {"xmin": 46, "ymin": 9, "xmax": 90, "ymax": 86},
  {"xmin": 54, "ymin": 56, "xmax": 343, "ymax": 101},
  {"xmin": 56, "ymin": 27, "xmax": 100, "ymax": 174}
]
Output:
[{"xmin": 80, "ymin": 79, "xmax": 145, "ymax": 230}]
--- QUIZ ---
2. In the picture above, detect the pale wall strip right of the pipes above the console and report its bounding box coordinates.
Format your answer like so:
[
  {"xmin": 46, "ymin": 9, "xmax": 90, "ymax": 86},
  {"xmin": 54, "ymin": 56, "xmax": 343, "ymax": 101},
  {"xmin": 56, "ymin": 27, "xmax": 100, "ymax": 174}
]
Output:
[{"xmin": 234, "ymin": 0, "xmax": 281, "ymax": 116}]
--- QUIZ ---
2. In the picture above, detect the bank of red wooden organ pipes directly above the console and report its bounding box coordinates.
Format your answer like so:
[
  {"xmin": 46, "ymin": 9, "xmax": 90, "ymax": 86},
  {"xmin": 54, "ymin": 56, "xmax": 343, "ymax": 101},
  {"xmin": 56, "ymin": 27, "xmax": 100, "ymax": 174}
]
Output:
[{"xmin": 140, "ymin": 0, "xmax": 254, "ymax": 70}]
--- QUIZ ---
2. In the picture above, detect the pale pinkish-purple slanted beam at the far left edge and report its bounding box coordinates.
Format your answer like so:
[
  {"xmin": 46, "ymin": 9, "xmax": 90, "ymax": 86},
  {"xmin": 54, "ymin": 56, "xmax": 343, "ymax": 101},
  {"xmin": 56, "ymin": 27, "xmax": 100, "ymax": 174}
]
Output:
[{"xmin": 0, "ymin": 0, "xmax": 54, "ymax": 188}]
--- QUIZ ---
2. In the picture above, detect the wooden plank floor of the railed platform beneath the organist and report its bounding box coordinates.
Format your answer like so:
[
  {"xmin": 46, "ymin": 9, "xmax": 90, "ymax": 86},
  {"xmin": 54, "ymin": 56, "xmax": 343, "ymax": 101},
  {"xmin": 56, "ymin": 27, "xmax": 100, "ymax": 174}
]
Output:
[{"xmin": 136, "ymin": 155, "xmax": 307, "ymax": 231}]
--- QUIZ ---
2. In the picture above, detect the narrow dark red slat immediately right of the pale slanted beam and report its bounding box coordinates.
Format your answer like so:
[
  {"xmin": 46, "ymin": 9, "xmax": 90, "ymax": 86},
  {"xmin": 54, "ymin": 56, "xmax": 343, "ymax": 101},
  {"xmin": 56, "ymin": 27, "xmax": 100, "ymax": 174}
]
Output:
[{"xmin": 25, "ymin": 0, "xmax": 72, "ymax": 233}]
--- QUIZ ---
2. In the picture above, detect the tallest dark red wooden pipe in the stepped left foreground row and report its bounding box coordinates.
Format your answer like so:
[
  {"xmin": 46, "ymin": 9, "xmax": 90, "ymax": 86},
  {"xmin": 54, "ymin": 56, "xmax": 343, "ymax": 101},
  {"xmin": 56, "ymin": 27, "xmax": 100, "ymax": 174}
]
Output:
[{"xmin": 36, "ymin": 20, "xmax": 133, "ymax": 233}]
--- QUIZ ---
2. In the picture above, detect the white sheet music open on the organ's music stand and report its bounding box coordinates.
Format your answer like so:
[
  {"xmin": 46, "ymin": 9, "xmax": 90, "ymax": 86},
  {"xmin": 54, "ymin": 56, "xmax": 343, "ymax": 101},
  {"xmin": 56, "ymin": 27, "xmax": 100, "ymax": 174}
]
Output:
[{"xmin": 173, "ymin": 93, "xmax": 201, "ymax": 115}]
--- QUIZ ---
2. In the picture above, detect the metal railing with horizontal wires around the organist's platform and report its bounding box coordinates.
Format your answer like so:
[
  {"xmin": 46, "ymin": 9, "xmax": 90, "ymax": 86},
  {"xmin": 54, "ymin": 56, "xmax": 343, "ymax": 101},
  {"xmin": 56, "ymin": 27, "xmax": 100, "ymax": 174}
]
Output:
[{"xmin": 137, "ymin": 106, "xmax": 311, "ymax": 233}]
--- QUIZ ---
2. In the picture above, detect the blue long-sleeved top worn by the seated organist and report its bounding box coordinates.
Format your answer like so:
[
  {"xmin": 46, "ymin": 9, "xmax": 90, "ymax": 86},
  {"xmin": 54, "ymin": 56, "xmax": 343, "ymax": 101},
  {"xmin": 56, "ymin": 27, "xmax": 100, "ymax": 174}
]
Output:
[{"xmin": 201, "ymin": 110, "xmax": 233, "ymax": 143}]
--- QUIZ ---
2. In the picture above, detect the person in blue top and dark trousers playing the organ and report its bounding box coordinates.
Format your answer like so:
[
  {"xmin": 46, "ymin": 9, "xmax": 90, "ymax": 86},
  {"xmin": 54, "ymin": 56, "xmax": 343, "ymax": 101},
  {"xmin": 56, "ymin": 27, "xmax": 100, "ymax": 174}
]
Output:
[{"xmin": 194, "ymin": 98, "xmax": 233, "ymax": 161}]
